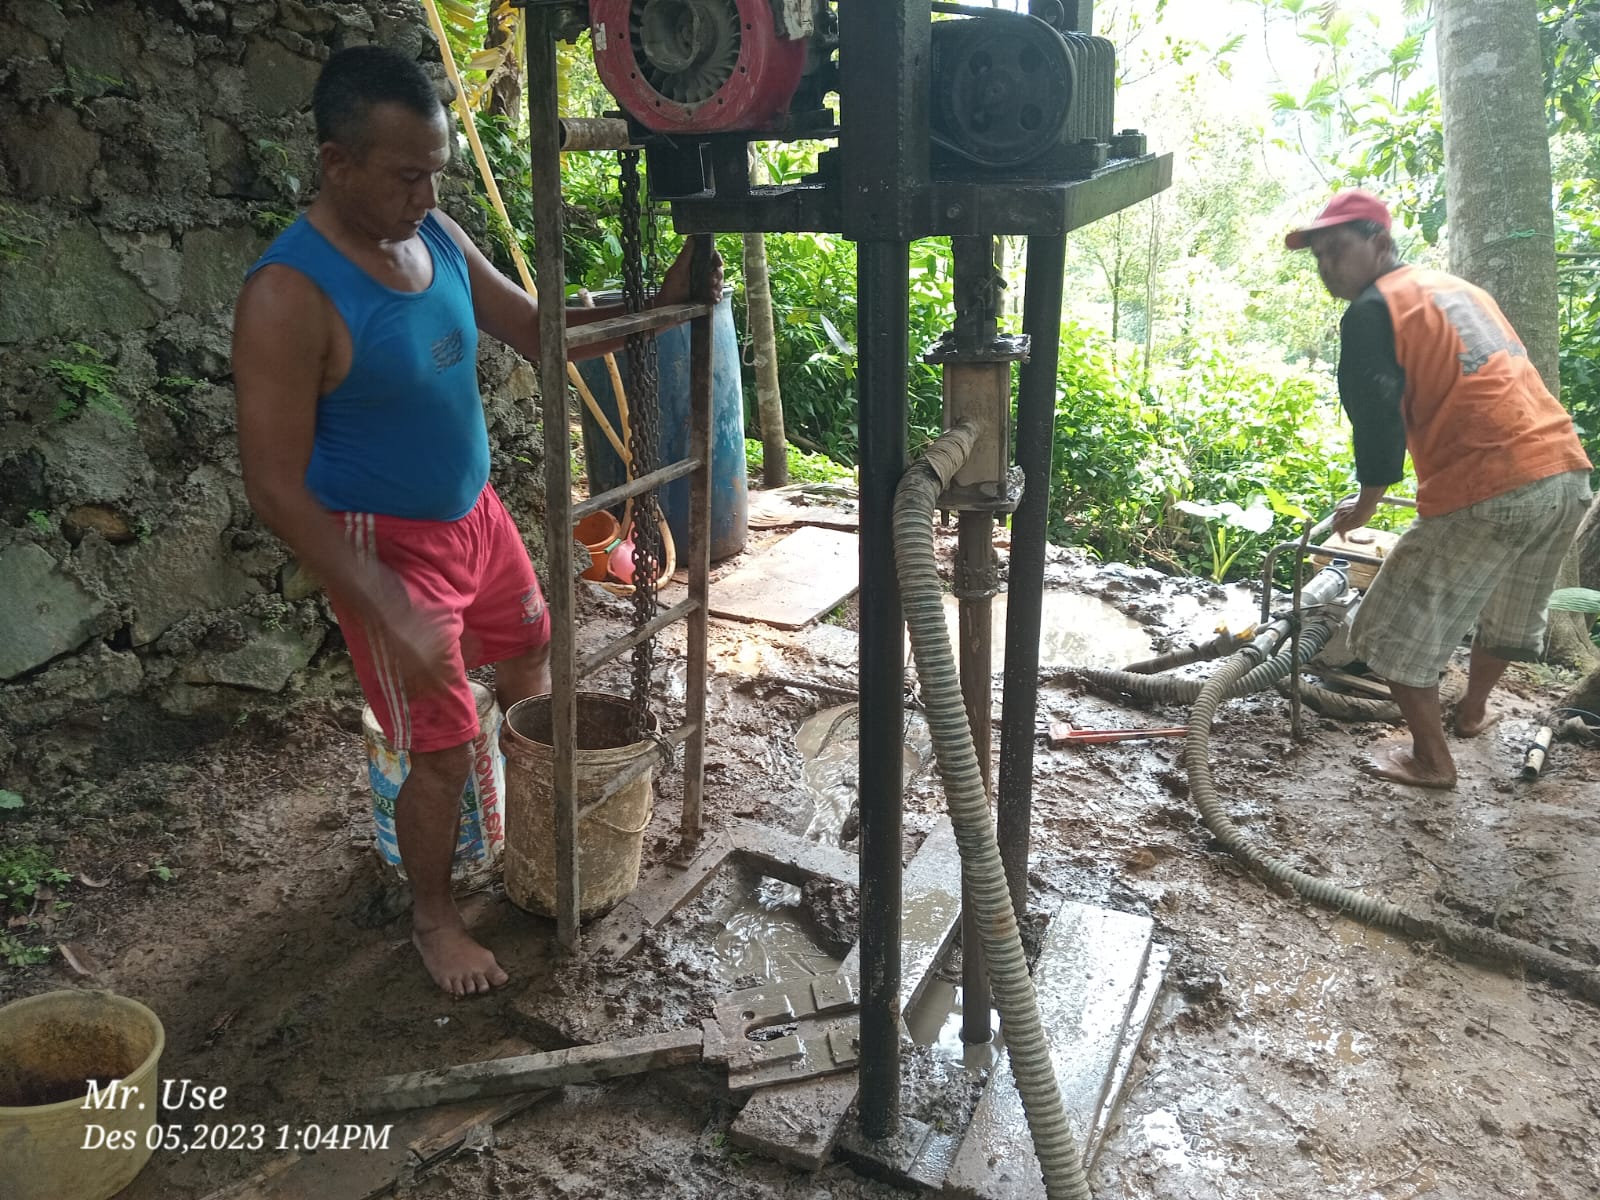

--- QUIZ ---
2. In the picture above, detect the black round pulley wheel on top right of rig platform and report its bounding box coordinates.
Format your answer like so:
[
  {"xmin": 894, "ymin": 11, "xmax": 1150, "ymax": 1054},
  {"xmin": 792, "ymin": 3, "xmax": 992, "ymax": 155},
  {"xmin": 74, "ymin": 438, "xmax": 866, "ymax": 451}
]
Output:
[{"xmin": 933, "ymin": 13, "xmax": 1077, "ymax": 166}]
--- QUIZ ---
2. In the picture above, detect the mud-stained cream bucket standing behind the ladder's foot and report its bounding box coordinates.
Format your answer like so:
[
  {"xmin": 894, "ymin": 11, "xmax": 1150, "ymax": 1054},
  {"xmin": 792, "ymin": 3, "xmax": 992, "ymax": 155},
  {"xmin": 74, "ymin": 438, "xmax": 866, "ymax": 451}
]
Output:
[{"xmin": 501, "ymin": 691, "xmax": 658, "ymax": 918}]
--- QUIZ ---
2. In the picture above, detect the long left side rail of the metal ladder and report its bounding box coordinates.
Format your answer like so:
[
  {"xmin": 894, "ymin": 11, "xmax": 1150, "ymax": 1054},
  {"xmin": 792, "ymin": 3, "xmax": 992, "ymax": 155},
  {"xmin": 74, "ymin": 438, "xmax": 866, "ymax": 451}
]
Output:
[{"xmin": 523, "ymin": 6, "xmax": 579, "ymax": 950}]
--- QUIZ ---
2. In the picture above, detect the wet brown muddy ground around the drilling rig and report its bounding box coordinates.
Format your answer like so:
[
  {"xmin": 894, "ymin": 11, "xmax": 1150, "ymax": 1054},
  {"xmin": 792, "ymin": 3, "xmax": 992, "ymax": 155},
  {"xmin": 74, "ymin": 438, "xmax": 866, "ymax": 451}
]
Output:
[{"xmin": 0, "ymin": 528, "xmax": 1600, "ymax": 1200}]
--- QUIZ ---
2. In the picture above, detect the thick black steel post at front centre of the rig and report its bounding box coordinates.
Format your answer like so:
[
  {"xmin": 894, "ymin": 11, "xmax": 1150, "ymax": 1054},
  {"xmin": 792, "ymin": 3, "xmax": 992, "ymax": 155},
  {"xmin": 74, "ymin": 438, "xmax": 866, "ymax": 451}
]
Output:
[{"xmin": 838, "ymin": 0, "xmax": 933, "ymax": 1139}]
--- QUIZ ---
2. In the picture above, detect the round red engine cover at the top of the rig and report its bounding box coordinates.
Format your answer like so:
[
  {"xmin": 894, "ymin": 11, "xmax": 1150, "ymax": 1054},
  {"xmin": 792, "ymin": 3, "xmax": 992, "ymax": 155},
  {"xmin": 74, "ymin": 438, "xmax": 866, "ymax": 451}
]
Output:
[{"xmin": 590, "ymin": 0, "xmax": 806, "ymax": 133}]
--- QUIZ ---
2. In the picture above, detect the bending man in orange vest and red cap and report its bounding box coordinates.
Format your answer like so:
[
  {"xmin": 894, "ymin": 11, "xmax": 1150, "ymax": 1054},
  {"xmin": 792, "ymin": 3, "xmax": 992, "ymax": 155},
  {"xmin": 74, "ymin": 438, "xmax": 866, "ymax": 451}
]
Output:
[{"xmin": 1285, "ymin": 190, "xmax": 1590, "ymax": 787}]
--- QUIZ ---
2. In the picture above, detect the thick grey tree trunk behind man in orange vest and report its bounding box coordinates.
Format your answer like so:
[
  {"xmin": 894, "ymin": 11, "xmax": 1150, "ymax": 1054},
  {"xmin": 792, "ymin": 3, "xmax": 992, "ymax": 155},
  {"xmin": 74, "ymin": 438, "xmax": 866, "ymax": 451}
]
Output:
[{"xmin": 1438, "ymin": 0, "xmax": 1600, "ymax": 669}]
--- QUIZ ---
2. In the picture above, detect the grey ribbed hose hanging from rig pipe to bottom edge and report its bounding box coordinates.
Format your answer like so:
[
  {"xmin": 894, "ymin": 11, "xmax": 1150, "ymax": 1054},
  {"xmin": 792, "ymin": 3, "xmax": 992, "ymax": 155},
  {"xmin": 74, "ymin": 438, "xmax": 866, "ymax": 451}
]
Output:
[{"xmin": 894, "ymin": 421, "xmax": 1090, "ymax": 1200}]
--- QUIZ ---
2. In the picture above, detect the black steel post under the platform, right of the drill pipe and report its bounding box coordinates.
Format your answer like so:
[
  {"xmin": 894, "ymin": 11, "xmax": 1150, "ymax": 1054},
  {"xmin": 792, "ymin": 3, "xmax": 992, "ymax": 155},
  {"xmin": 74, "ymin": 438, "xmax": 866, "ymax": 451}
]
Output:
[{"xmin": 995, "ymin": 237, "xmax": 1067, "ymax": 922}]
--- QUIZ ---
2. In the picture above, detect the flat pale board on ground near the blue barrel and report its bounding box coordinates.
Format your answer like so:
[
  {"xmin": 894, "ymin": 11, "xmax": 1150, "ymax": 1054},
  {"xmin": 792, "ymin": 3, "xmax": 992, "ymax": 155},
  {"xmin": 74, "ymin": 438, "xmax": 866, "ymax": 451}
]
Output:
[{"xmin": 710, "ymin": 525, "xmax": 859, "ymax": 629}]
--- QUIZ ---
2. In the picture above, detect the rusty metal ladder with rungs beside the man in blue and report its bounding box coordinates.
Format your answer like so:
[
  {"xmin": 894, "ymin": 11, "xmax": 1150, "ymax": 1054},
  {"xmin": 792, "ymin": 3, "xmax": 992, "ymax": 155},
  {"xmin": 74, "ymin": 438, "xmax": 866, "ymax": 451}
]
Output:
[{"xmin": 523, "ymin": 0, "xmax": 714, "ymax": 952}]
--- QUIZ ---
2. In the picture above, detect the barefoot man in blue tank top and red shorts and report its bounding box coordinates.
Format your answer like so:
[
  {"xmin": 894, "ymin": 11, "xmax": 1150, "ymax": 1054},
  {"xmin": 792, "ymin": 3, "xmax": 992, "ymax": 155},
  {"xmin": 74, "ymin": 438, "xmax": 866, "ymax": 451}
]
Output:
[{"xmin": 234, "ymin": 46, "xmax": 720, "ymax": 995}]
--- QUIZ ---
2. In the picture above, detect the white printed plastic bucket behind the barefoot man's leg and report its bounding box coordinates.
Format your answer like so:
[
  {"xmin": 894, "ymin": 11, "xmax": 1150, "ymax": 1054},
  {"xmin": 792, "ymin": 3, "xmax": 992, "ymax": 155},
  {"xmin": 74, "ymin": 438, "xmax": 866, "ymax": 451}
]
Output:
[{"xmin": 362, "ymin": 682, "xmax": 506, "ymax": 886}]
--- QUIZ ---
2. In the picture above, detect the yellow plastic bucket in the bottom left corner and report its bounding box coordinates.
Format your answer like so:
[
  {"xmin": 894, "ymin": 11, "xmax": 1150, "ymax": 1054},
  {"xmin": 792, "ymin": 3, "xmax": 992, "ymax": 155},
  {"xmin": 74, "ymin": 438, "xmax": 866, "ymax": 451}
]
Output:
[{"xmin": 0, "ymin": 992, "xmax": 166, "ymax": 1200}]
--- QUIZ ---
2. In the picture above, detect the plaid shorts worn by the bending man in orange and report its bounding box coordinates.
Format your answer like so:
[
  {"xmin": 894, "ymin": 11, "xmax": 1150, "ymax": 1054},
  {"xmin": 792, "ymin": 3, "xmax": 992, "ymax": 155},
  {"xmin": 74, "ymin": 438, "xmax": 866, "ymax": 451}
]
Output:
[{"xmin": 1350, "ymin": 470, "xmax": 1589, "ymax": 688}]
